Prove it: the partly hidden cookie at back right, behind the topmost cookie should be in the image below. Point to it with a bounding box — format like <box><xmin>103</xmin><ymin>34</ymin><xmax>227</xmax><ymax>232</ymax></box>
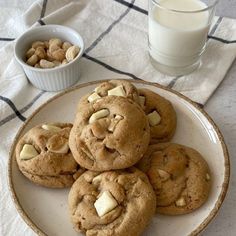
<box><xmin>138</xmin><ymin>89</ymin><xmax>177</xmax><ymax>143</ymax></box>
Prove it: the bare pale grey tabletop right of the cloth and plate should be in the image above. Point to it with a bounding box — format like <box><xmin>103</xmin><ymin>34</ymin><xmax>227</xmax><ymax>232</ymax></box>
<box><xmin>200</xmin><ymin>0</ymin><xmax>236</xmax><ymax>236</ymax></box>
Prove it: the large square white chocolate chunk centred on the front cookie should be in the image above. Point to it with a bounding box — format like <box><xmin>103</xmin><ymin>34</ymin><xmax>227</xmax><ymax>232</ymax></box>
<box><xmin>94</xmin><ymin>191</ymin><xmax>118</xmax><ymax>217</ymax></box>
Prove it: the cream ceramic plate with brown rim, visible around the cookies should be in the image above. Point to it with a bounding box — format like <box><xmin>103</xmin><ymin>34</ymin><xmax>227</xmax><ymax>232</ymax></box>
<box><xmin>9</xmin><ymin>81</ymin><xmax>229</xmax><ymax>236</ymax></box>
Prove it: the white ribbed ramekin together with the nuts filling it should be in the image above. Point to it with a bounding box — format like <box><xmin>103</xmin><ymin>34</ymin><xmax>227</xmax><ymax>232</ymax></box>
<box><xmin>15</xmin><ymin>25</ymin><xmax>84</xmax><ymax>91</ymax></box>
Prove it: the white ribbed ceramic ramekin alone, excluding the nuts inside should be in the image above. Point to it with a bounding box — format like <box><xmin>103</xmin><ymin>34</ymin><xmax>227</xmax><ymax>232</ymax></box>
<box><xmin>15</xmin><ymin>25</ymin><xmax>84</xmax><ymax>91</ymax></box>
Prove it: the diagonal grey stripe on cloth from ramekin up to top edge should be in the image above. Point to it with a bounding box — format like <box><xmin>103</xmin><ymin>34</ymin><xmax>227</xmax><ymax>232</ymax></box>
<box><xmin>84</xmin><ymin>0</ymin><xmax>135</xmax><ymax>53</ymax></box>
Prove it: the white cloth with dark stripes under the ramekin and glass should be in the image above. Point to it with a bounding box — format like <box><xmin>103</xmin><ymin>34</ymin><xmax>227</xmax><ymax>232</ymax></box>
<box><xmin>0</xmin><ymin>0</ymin><xmax>236</xmax><ymax>236</ymax></box>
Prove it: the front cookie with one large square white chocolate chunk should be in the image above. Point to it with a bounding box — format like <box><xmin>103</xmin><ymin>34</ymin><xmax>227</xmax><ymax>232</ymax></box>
<box><xmin>68</xmin><ymin>167</ymin><xmax>156</xmax><ymax>236</ymax></box>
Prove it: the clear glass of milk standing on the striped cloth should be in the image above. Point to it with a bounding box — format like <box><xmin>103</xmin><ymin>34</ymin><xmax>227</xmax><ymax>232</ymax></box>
<box><xmin>148</xmin><ymin>0</ymin><xmax>218</xmax><ymax>76</ymax></box>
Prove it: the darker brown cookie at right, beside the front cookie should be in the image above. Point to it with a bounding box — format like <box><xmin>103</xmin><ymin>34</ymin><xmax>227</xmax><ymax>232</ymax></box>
<box><xmin>137</xmin><ymin>143</ymin><xmax>211</xmax><ymax>215</ymax></box>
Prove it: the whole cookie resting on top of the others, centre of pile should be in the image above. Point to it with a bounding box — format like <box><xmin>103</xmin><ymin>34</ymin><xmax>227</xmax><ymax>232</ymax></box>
<box><xmin>69</xmin><ymin>96</ymin><xmax>150</xmax><ymax>171</ymax></box>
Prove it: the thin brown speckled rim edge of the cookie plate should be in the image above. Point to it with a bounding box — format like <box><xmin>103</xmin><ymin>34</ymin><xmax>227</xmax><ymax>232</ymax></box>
<box><xmin>7</xmin><ymin>78</ymin><xmax>230</xmax><ymax>236</ymax></box>
